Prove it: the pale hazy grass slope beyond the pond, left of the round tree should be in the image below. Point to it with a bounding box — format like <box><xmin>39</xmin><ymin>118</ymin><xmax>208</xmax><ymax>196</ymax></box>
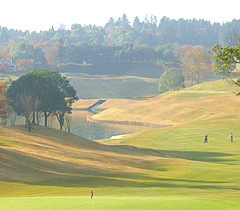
<box><xmin>63</xmin><ymin>73</ymin><xmax>159</xmax><ymax>99</ymax></box>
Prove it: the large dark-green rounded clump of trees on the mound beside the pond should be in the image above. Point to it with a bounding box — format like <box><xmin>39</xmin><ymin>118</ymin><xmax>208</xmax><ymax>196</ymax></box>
<box><xmin>7</xmin><ymin>69</ymin><xmax>78</xmax><ymax>129</ymax></box>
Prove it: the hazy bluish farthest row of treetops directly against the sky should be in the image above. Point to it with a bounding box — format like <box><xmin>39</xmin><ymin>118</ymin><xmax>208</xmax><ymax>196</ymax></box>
<box><xmin>0</xmin><ymin>14</ymin><xmax>240</xmax><ymax>48</ymax></box>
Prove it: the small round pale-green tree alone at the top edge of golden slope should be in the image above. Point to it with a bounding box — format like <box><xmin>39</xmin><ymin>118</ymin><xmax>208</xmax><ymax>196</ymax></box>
<box><xmin>158</xmin><ymin>67</ymin><xmax>184</xmax><ymax>92</ymax></box>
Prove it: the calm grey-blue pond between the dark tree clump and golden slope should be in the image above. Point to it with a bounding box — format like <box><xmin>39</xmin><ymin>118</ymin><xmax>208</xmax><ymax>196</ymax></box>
<box><xmin>13</xmin><ymin>111</ymin><xmax>153</xmax><ymax>140</ymax></box>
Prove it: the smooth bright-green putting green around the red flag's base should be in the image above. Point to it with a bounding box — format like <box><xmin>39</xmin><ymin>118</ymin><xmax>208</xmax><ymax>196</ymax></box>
<box><xmin>0</xmin><ymin>196</ymin><xmax>240</xmax><ymax>210</ymax></box>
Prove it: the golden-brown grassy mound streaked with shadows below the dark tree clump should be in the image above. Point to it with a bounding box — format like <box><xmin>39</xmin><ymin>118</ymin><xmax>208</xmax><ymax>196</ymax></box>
<box><xmin>0</xmin><ymin>126</ymin><xmax>168</xmax><ymax>197</ymax></box>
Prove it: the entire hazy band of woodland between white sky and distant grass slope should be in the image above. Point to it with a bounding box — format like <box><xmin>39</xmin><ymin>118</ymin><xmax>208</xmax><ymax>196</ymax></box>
<box><xmin>0</xmin><ymin>14</ymin><xmax>240</xmax><ymax>78</ymax></box>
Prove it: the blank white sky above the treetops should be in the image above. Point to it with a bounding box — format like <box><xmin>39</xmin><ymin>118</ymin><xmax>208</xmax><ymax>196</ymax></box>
<box><xmin>0</xmin><ymin>0</ymin><xmax>240</xmax><ymax>32</ymax></box>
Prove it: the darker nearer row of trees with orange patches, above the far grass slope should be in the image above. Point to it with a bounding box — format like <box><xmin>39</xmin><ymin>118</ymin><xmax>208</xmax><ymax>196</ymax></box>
<box><xmin>0</xmin><ymin>38</ymin><xmax>212</xmax><ymax>77</ymax></box>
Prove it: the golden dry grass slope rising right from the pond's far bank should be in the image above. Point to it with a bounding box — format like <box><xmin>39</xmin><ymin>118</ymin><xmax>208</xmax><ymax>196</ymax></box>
<box><xmin>92</xmin><ymin>81</ymin><xmax>240</xmax><ymax>125</ymax></box>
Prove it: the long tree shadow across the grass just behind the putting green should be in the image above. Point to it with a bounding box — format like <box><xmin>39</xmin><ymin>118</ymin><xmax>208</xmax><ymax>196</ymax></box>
<box><xmin>4</xmin><ymin>171</ymin><xmax>240</xmax><ymax>191</ymax></box>
